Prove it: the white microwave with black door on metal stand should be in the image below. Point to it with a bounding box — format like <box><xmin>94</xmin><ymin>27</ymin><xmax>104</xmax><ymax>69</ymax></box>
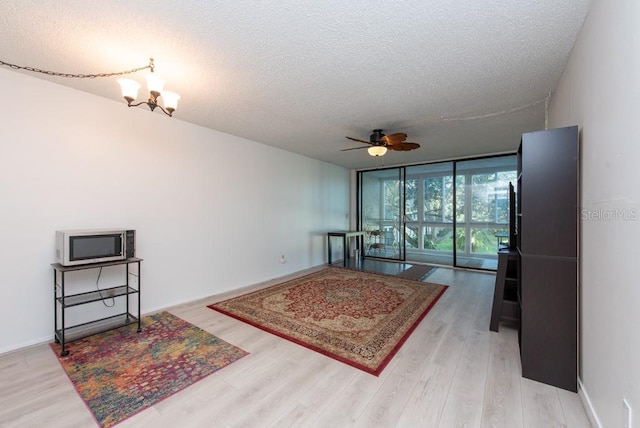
<box><xmin>56</xmin><ymin>229</ymin><xmax>136</xmax><ymax>266</ymax></box>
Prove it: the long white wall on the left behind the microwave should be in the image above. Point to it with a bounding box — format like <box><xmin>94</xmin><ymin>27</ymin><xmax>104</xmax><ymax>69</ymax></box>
<box><xmin>0</xmin><ymin>69</ymin><xmax>350</xmax><ymax>353</ymax></box>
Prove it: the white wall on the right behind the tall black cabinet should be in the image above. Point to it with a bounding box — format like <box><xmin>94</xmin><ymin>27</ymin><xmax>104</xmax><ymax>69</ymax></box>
<box><xmin>550</xmin><ymin>0</ymin><xmax>640</xmax><ymax>427</ymax></box>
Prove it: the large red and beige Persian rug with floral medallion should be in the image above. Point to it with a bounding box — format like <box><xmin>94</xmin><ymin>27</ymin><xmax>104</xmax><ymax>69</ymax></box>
<box><xmin>209</xmin><ymin>268</ymin><xmax>447</xmax><ymax>376</ymax></box>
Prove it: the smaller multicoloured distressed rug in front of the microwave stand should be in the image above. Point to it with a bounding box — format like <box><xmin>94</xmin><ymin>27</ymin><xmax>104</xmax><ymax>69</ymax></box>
<box><xmin>51</xmin><ymin>312</ymin><xmax>247</xmax><ymax>427</ymax></box>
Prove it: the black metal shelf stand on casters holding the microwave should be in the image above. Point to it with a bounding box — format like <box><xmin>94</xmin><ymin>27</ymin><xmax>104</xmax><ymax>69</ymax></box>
<box><xmin>51</xmin><ymin>257</ymin><xmax>142</xmax><ymax>356</ymax></box>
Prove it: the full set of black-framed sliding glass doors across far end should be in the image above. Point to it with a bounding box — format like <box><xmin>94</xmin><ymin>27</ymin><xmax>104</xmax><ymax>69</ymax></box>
<box><xmin>358</xmin><ymin>156</ymin><xmax>516</xmax><ymax>270</ymax></box>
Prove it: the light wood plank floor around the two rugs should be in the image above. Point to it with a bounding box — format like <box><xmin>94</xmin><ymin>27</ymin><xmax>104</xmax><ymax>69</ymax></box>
<box><xmin>0</xmin><ymin>268</ymin><xmax>589</xmax><ymax>428</ymax></box>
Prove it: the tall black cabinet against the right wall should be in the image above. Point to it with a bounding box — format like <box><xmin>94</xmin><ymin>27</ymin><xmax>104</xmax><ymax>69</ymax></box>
<box><xmin>517</xmin><ymin>126</ymin><xmax>579</xmax><ymax>391</ymax></box>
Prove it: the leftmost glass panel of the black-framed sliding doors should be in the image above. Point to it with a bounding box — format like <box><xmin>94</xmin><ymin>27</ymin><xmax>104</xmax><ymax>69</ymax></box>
<box><xmin>358</xmin><ymin>168</ymin><xmax>405</xmax><ymax>260</ymax></box>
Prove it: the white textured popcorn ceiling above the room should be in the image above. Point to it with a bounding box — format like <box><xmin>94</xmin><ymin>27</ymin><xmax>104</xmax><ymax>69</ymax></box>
<box><xmin>0</xmin><ymin>0</ymin><xmax>591</xmax><ymax>168</ymax></box>
